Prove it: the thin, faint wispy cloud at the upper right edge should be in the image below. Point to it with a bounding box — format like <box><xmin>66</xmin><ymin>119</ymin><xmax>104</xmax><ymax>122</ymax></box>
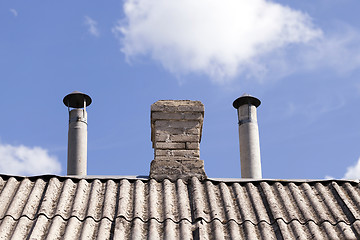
<box><xmin>272</xmin><ymin>23</ymin><xmax>360</xmax><ymax>75</ymax></box>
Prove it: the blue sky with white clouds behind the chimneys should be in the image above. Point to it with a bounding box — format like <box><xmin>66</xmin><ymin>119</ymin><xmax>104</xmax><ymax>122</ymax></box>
<box><xmin>0</xmin><ymin>0</ymin><xmax>360</xmax><ymax>179</ymax></box>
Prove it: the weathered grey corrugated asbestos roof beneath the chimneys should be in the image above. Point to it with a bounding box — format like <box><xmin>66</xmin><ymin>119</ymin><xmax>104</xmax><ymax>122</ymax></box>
<box><xmin>0</xmin><ymin>175</ymin><xmax>360</xmax><ymax>239</ymax></box>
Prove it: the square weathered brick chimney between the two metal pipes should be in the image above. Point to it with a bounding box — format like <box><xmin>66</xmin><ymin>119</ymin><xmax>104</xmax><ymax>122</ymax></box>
<box><xmin>150</xmin><ymin>100</ymin><xmax>206</xmax><ymax>180</ymax></box>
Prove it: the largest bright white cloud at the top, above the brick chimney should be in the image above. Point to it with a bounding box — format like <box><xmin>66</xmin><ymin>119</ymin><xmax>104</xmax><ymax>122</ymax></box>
<box><xmin>113</xmin><ymin>0</ymin><xmax>322</xmax><ymax>82</ymax></box>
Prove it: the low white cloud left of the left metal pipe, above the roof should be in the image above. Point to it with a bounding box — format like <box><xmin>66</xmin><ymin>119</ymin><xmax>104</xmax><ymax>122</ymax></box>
<box><xmin>0</xmin><ymin>144</ymin><xmax>61</xmax><ymax>175</ymax></box>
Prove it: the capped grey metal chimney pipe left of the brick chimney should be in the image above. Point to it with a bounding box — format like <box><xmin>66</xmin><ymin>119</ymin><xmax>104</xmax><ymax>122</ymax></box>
<box><xmin>63</xmin><ymin>91</ymin><xmax>92</xmax><ymax>175</ymax></box>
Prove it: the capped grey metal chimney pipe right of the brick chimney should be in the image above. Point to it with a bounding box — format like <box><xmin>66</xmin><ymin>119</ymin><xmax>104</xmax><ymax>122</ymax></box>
<box><xmin>233</xmin><ymin>94</ymin><xmax>262</xmax><ymax>179</ymax></box>
